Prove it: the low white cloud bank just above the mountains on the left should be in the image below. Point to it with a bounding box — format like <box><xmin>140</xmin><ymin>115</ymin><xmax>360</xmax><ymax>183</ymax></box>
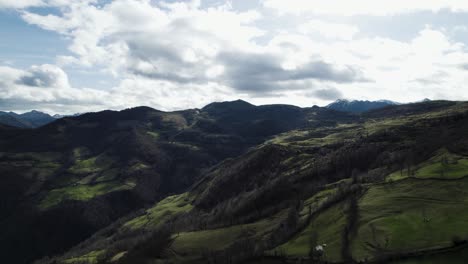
<box><xmin>0</xmin><ymin>65</ymin><xmax>238</xmax><ymax>113</ymax></box>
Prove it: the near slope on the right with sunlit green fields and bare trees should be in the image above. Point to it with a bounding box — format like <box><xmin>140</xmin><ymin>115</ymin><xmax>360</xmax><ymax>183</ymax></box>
<box><xmin>44</xmin><ymin>102</ymin><xmax>468</xmax><ymax>263</ymax></box>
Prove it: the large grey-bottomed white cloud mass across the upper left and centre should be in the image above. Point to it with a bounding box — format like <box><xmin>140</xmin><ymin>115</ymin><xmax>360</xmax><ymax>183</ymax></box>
<box><xmin>15</xmin><ymin>0</ymin><xmax>370</xmax><ymax>101</ymax></box>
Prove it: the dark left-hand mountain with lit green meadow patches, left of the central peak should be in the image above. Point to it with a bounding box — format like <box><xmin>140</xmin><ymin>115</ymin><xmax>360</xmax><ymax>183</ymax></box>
<box><xmin>0</xmin><ymin>108</ymin><xmax>218</xmax><ymax>263</ymax></box>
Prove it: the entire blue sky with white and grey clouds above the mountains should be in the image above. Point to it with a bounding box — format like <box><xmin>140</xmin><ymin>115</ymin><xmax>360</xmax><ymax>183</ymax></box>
<box><xmin>0</xmin><ymin>0</ymin><xmax>468</xmax><ymax>114</ymax></box>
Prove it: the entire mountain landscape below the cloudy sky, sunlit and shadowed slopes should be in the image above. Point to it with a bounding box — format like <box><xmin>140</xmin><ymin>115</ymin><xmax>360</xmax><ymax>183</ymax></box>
<box><xmin>0</xmin><ymin>100</ymin><xmax>468</xmax><ymax>264</ymax></box>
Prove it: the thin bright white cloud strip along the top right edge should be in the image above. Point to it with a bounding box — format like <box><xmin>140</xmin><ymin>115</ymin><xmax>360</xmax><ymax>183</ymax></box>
<box><xmin>263</xmin><ymin>0</ymin><xmax>468</xmax><ymax>16</ymax></box>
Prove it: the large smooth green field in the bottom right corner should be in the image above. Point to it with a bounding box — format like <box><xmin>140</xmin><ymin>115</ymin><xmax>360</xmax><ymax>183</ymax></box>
<box><xmin>352</xmin><ymin>176</ymin><xmax>468</xmax><ymax>260</ymax></box>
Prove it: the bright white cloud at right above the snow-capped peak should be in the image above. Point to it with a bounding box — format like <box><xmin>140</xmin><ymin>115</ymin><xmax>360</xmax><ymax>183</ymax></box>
<box><xmin>323</xmin><ymin>28</ymin><xmax>468</xmax><ymax>102</ymax></box>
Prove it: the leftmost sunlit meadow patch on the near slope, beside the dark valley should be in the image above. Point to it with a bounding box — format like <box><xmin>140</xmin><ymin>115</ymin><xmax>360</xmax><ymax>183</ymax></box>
<box><xmin>124</xmin><ymin>193</ymin><xmax>193</xmax><ymax>229</ymax></box>
